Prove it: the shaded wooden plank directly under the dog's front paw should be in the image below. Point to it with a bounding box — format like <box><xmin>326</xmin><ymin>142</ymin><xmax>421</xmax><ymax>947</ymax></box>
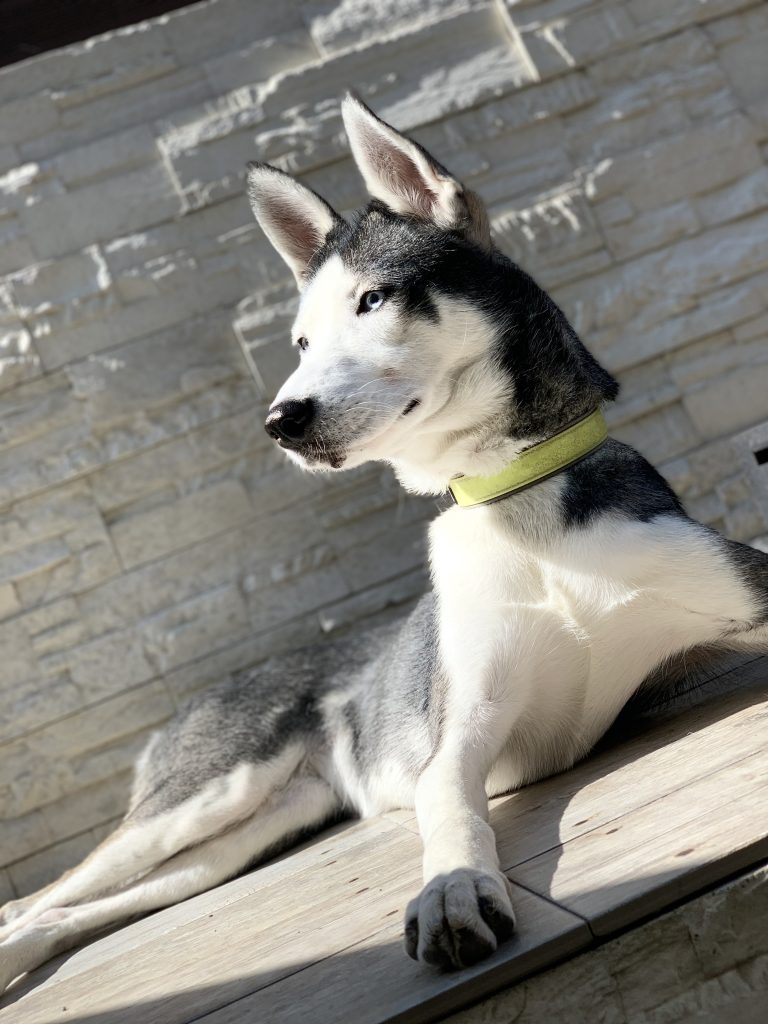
<box><xmin>195</xmin><ymin>887</ymin><xmax>593</xmax><ymax>1024</ymax></box>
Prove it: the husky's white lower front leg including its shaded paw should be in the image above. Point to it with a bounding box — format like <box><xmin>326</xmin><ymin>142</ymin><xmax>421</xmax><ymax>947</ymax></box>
<box><xmin>406</xmin><ymin>737</ymin><xmax>515</xmax><ymax>969</ymax></box>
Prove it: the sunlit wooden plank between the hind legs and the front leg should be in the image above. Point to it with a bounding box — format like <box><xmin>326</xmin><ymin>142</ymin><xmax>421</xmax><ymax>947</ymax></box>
<box><xmin>0</xmin><ymin>825</ymin><xmax>428</xmax><ymax>1024</ymax></box>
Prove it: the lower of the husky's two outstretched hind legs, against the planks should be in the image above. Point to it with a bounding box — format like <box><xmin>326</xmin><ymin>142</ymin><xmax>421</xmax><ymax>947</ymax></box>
<box><xmin>0</xmin><ymin>769</ymin><xmax>340</xmax><ymax>992</ymax></box>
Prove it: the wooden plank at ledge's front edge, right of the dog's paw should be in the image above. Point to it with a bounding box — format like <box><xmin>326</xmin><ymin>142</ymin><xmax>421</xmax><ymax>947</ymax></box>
<box><xmin>511</xmin><ymin>751</ymin><xmax>768</xmax><ymax>935</ymax></box>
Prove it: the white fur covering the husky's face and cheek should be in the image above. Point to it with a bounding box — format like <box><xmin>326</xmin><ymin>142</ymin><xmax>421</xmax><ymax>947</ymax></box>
<box><xmin>274</xmin><ymin>256</ymin><xmax>523</xmax><ymax>494</ymax></box>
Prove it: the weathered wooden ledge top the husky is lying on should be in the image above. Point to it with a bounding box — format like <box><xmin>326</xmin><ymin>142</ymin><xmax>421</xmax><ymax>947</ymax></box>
<box><xmin>0</xmin><ymin>658</ymin><xmax>768</xmax><ymax>1024</ymax></box>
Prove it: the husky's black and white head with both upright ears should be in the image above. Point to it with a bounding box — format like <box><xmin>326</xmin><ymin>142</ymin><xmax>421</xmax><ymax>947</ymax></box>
<box><xmin>248</xmin><ymin>96</ymin><xmax>609</xmax><ymax>490</ymax></box>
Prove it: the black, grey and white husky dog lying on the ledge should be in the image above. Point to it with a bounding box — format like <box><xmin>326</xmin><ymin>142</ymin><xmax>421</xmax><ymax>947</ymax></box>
<box><xmin>0</xmin><ymin>96</ymin><xmax>768</xmax><ymax>986</ymax></box>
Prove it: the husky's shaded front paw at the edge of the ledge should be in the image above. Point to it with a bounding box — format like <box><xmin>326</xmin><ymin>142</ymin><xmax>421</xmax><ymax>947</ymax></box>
<box><xmin>406</xmin><ymin>868</ymin><xmax>515</xmax><ymax>971</ymax></box>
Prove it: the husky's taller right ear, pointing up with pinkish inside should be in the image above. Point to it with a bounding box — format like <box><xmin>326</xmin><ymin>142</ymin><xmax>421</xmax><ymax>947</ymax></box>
<box><xmin>341</xmin><ymin>92</ymin><xmax>490</xmax><ymax>248</ymax></box>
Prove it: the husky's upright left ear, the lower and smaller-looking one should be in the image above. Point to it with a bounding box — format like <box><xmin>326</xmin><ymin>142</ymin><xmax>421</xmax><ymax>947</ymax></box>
<box><xmin>248</xmin><ymin>163</ymin><xmax>343</xmax><ymax>290</ymax></box>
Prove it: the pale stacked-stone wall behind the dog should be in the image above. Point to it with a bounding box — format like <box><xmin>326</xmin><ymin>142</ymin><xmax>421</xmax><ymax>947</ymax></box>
<box><xmin>0</xmin><ymin>0</ymin><xmax>768</xmax><ymax>897</ymax></box>
